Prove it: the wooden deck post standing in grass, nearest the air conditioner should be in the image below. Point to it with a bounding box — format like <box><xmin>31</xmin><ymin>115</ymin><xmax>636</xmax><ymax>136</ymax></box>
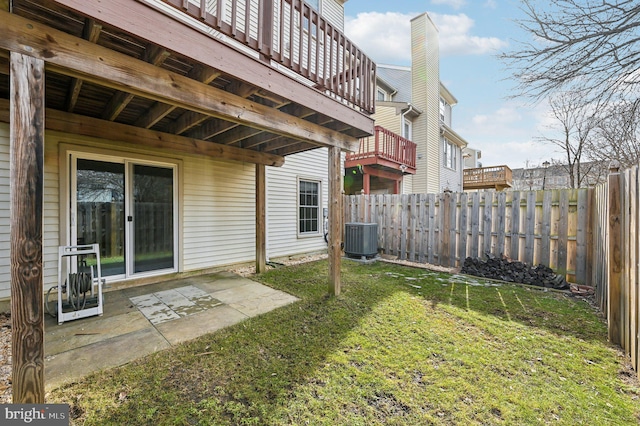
<box><xmin>329</xmin><ymin>146</ymin><xmax>343</xmax><ymax>296</ymax></box>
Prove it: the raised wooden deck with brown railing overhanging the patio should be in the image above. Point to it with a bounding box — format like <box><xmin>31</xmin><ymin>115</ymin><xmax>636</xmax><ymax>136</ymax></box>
<box><xmin>0</xmin><ymin>0</ymin><xmax>375</xmax><ymax>166</ymax></box>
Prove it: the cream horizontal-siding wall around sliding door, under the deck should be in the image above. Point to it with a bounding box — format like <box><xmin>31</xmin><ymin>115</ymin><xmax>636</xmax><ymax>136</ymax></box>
<box><xmin>0</xmin><ymin>123</ymin><xmax>328</xmax><ymax>300</ymax></box>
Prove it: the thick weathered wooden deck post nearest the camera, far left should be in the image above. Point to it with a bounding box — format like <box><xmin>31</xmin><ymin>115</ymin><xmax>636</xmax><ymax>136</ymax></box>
<box><xmin>9</xmin><ymin>52</ymin><xmax>44</xmax><ymax>404</ymax></box>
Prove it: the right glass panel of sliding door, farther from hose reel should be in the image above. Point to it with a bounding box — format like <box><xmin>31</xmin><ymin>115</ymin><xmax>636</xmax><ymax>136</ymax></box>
<box><xmin>133</xmin><ymin>164</ymin><xmax>174</xmax><ymax>272</ymax></box>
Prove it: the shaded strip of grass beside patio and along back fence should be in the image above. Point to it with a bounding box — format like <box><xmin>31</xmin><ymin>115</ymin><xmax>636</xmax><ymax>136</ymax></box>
<box><xmin>52</xmin><ymin>261</ymin><xmax>606</xmax><ymax>425</ymax></box>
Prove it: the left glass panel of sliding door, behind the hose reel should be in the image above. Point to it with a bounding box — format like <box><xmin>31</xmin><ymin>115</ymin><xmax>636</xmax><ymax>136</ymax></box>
<box><xmin>76</xmin><ymin>159</ymin><xmax>125</xmax><ymax>276</ymax></box>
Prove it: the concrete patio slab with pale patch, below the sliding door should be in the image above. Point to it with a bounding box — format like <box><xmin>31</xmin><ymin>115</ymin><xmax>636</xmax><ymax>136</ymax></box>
<box><xmin>45</xmin><ymin>272</ymin><xmax>298</xmax><ymax>390</ymax></box>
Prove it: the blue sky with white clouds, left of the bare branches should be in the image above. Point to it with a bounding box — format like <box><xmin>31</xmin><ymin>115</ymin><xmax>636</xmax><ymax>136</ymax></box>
<box><xmin>345</xmin><ymin>0</ymin><xmax>560</xmax><ymax>169</ymax></box>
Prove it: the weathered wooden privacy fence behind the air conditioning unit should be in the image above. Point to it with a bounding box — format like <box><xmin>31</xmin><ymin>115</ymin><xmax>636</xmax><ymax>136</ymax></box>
<box><xmin>345</xmin><ymin>189</ymin><xmax>591</xmax><ymax>284</ymax></box>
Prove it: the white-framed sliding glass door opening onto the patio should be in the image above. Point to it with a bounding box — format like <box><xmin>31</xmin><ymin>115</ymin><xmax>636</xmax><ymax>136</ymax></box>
<box><xmin>71</xmin><ymin>156</ymin><xmax>176</xmax><ymax>278</ymax></box>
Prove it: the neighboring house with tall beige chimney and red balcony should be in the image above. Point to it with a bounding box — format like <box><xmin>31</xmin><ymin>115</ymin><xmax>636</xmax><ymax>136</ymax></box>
<box><xmin>345</xmin><ymin>13</ymin><xmax>467</xmax><ymax>194</ymax></box>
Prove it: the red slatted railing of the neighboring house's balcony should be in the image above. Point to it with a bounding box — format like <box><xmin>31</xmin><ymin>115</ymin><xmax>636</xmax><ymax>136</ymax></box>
<box><xmin>346</xmin><ymin>126</ymin><xmax>416</xmax><ymax>171</ymax></box>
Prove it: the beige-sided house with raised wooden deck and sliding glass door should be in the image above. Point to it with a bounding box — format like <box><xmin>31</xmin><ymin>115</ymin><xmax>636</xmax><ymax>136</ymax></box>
<box><xmin>0</xmin><ymin>0</ymin><xmax>375</xmax><ymax>300</ymax></box>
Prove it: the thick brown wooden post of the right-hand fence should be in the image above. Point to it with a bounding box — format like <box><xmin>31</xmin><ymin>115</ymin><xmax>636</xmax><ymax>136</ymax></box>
<box><xmin>607</xmin><ymin>165</ymin><xmax>623</xmax><ymax>345</ymax></box>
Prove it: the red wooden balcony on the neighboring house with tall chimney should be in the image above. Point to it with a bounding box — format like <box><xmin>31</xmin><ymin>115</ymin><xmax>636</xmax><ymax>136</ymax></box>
<box><xmin>345</xmin><ymin>126</ymin><xmax>416</xmax><ymax>174</ymax></box>
